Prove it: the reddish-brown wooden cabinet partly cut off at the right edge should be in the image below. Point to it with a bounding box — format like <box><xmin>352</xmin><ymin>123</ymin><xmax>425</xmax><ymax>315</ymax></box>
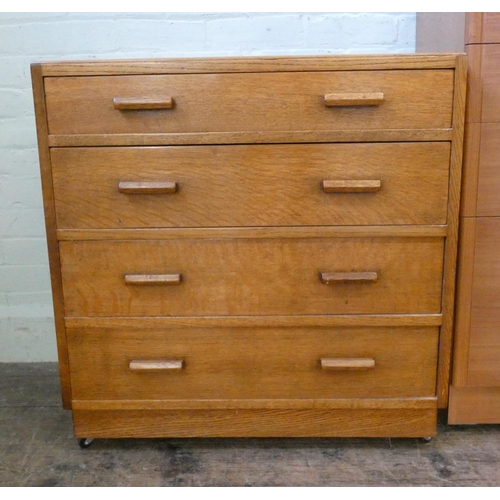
<box><xmin>449</xmin><ymin>13</ymin><xmax>500</xmax><ymax>423</ymax></box>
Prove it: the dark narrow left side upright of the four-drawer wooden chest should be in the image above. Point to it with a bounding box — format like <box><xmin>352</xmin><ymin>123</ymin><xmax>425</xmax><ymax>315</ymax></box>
<box><xmin>31</xmin><ymin>64</ymin><xmax>71</xmax><ymax>409</ymax></box>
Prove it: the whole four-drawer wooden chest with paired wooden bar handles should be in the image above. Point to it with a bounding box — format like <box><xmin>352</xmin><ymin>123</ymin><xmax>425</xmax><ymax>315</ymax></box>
<box><xmin>32</xmin><ymin>54</ymin><xmax>466</xmax><ymax>437</ymax></box>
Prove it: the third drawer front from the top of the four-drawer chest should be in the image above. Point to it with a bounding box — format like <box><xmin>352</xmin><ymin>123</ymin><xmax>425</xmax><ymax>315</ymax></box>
<box><xmin>60</xmin><ymin>237</ymin><xmax>443</xmax><ymax>316</ymax></box>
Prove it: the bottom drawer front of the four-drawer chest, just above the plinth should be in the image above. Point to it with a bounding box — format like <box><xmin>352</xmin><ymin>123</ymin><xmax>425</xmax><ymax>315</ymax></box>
<box><xmin>68</xmin><ymin>327</ymin><xmax>438</xmax><ymax>400</ymax></box>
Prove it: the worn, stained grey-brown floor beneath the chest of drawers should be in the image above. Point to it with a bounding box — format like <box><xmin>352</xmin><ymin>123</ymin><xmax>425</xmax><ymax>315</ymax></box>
<box><xmin>0</xmin><ymin>363</ymin><xmax>500</xmax><ymax>487</ymax></box>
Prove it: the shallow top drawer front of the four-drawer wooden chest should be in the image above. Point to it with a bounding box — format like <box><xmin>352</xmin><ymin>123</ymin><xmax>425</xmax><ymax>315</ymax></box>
<box><xmin>45</xmin><ymin>69</ymin><xmax>454</xmax><ymax>135</ymax></box>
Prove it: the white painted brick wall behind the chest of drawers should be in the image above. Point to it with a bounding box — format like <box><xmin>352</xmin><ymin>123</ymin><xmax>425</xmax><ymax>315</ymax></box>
<box><xmin>0</xmin><ymin>12</ymin><xmax>416</xmax><ymax>362</ymax></box>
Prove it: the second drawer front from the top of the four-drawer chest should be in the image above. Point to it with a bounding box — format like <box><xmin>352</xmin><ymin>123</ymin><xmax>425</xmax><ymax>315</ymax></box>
<box><xmin>51</xmin><ymin>143</ymin><xmax>450</xmax><ymax>229</ymax></box>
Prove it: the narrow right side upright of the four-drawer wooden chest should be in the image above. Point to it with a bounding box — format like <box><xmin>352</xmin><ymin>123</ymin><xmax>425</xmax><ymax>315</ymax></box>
<box><xmin>438</xmin><ymin>55</ymin><xmax>467</xmax><ymax>408</ymax></box>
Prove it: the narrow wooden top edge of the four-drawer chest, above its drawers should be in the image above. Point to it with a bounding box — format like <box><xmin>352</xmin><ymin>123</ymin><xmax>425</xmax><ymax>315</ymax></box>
<box><xmin>38</xmin><ymin>54</ymin><xmax>456</xmax><ymax>77</ymax></box>
